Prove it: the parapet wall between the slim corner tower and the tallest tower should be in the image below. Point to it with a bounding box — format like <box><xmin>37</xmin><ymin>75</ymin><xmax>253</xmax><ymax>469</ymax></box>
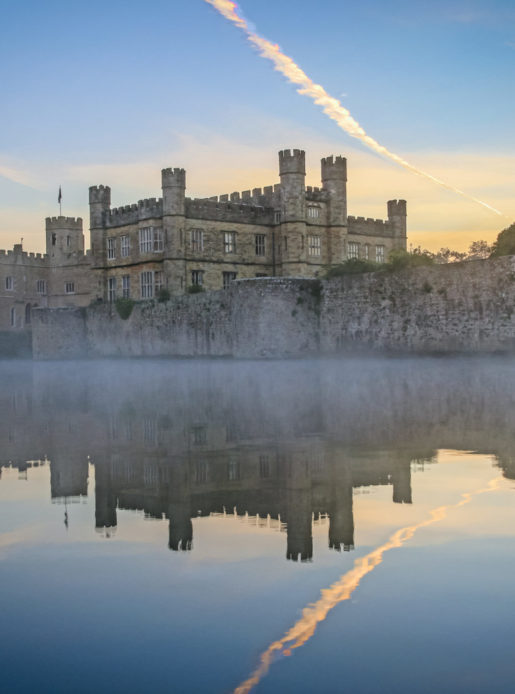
<box><xmin>186</xmin><ymin>195</ymin><xmax>275</xmax><ymax>224</ymax></box>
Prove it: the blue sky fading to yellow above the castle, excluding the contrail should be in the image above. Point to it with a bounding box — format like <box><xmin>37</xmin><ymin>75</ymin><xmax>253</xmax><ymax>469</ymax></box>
<box><xmin>0</xmin><ymin>0</ymin><xmax>515</xmax><ymax>252</ymax></box>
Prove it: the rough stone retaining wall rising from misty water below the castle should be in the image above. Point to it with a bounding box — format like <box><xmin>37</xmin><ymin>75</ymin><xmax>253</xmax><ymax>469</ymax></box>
<box><xmin>33</xmin><ymin>256</ymin><xmax>515</xmax><ymax>359</ymax></box>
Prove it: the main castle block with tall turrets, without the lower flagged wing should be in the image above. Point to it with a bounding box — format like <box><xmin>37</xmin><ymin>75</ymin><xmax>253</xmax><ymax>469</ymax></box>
<box><xmin>89</xmin><ymin>150</ymin><xmax>406</xmax><ymax>301</ymax></box>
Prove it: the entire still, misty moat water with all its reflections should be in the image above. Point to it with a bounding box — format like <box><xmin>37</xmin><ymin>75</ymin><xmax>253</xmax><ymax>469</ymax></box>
<box><xmin>0</xmin><ymin>358</ymin><xmax>515</xmax><ymax>694</ymax></box>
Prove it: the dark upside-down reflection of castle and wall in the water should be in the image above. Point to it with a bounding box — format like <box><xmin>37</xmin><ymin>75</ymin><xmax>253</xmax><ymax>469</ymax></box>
<box><xmin>0</xmin><ymin>359</ymin><xmax>515</xmax><ymax>561</ymax></box>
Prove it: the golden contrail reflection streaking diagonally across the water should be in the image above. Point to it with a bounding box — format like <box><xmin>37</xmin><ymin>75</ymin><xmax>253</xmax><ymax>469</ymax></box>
<box><xmin>234</xmin><ymin>477</ymin><xmax>502</xmax><ymax>694</ymax></box>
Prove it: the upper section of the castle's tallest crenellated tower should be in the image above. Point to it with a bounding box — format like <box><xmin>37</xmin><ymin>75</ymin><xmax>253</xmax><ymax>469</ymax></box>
<box><xmin>279</xmin><ymin>149</ymin><xmax>306</xmax><ymax>222</ymax></box>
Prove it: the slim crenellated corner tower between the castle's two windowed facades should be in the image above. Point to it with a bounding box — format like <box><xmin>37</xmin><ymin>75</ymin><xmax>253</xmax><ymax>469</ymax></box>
<box><xmin>161</xmin><ymin>168</ymin><xmax>189</xmax><ymax>294</ymax></box>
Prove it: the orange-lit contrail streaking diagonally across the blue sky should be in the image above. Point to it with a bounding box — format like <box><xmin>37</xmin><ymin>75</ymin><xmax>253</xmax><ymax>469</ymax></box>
<box><xmin>205</xmin><ymin>0</ymin><xmax>506</xmax><ymax>217</ymax></box>
